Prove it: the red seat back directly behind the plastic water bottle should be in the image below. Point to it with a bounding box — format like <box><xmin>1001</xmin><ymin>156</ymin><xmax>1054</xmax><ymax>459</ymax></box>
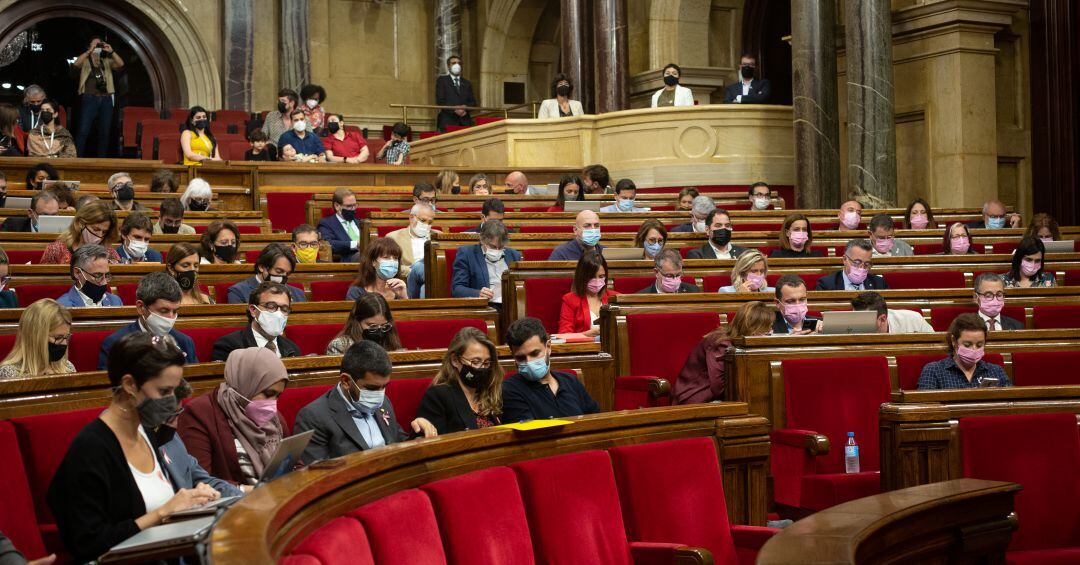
<box><xmin>782</xmin><ymin>357</ymin><xmax>892</xmax><ymax>473</ymax></box>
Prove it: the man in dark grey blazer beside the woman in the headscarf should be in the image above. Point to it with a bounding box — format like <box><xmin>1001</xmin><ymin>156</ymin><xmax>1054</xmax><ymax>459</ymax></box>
<box><xmin>293</xmin><ymin>339</ymin><xmax>437</xmax><ymax>465</ymax></box>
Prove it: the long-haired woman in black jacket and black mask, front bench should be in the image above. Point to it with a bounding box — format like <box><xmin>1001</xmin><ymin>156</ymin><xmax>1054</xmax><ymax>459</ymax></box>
<box><xmin>416</xmin><ymin>327</ymin><xmax>502</xmax><ymax>435</ymax></box>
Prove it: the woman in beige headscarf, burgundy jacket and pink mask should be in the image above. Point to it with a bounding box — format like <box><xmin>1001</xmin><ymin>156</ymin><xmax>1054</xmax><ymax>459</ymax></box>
<box><xmin>177</xmin><ymin>347</ymin><xmax>288</xmax><ymax>485</ymax></box>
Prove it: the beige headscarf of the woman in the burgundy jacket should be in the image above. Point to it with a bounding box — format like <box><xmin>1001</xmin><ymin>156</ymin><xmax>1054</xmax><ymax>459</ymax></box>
<box><xmin>217</xmin><ymin>347</ymin><xmax>288</xmax><ymax>479</ymax></box>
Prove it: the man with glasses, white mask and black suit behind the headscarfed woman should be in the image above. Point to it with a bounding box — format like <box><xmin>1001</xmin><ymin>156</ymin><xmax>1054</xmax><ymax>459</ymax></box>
<box><xmin>212</xmin><ymin>282</ymin><xmax>300</xmax><ymax>361</ymax></box>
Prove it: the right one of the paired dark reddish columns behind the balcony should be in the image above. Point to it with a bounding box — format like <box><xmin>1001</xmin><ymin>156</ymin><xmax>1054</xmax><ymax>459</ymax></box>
<box><xmin>593</xmin><ymin>0</ymin><xmax>630</xmax><ymax>113</ymax></box>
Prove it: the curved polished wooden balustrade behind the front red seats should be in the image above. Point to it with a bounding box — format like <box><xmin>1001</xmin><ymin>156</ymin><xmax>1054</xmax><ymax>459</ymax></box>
<box><xmin>208</xmin><ymin>403</ymin><xmax>769</xmax><ymax>565</ymax></box>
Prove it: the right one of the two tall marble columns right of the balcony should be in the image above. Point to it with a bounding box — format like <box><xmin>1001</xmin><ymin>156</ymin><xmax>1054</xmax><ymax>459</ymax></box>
<box><xmin>843</xmin><ymin>0</ymin><xmax>896</xmax><ymax>207</ymax></box>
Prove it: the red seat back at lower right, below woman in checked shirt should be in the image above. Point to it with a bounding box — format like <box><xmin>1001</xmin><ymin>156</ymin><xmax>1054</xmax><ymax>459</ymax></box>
<box><xmin>960</xmin><ymin>414</ymin><xmax>1080</xmax><ymax>550</ymax></box>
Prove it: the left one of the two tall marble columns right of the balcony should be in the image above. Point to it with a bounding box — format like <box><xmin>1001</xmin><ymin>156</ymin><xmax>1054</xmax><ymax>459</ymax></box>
<box><xmin>792</xmin><ymin>0</ymin><xmax>840</xmax><ymax>208</ymax></box>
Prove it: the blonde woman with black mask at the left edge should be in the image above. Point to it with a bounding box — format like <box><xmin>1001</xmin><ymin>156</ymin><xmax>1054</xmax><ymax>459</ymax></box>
<box><xmin>0</xmin><ymin>298</ymin><xmax>75</xmax><ymax>380</ymax></box>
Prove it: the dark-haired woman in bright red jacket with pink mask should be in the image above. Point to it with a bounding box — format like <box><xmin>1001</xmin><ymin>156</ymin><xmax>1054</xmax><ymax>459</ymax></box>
<box><xmin>558</xmin><ymin>251</ymin><xmax>619</xmax><ymax>337</ymax></box>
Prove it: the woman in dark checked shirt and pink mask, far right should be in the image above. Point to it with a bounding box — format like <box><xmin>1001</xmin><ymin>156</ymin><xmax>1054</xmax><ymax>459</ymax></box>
<box><xmin>919</xmin><ymin>313</ymin><xmax>1012</xmax><ymax>390</ymax></box>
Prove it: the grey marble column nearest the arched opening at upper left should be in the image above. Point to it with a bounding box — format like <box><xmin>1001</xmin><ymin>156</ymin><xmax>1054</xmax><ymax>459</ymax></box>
<box><xmin>221</xmin><ymin>0</ymin><xmax>255</xmax><ymax>110</ymax></box>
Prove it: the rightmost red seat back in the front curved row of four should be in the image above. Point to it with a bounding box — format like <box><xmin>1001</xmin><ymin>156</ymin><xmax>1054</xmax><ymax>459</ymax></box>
<box><xmin>608</xmin><ymin>438</ymin><xmax>739</xmax><ymax>565</ymax></box>
